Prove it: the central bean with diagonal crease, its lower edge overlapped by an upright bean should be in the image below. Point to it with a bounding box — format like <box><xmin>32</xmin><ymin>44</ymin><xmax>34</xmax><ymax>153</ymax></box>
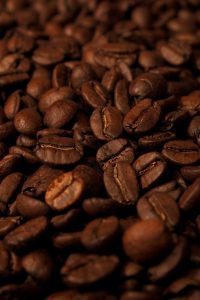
<box><xmin>96</xmin><ymin>138</ymin><xmax>135</xmax><ymax>170</ymax></box>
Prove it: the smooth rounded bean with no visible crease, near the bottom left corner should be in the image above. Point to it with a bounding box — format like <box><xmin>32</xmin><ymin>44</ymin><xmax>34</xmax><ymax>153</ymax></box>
<box><xmin>22</xmin><ymin>249</ymin><xmax>54</xmax><ymax>283</ymax></box>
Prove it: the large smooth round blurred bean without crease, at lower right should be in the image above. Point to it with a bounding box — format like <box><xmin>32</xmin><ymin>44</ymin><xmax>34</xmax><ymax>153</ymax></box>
<box><xmin>122</xmin><ymin>219</ymin><xmax>172</xmax><ymax>263</ymax></box>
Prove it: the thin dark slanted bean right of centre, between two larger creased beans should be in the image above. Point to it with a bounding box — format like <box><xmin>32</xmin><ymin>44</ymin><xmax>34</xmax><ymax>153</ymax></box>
<box><xmin>138</xmin><ymin>131</ymin><xmax>176</xmax><ymax>150</ymax></box>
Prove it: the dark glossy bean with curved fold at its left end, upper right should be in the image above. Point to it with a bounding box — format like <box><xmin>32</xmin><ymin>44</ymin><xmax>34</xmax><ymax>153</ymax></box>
<box><xmin>129</xmin><ymin>72</ymin><xmax>167</xmax><ymax>101</ymax></box>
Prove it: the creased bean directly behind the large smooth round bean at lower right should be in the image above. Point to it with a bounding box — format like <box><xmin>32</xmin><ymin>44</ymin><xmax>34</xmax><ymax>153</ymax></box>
<box><xmin>137</xmin><ymin>192</ymin><xmax>180</xmax><ymax>229</ymax></box>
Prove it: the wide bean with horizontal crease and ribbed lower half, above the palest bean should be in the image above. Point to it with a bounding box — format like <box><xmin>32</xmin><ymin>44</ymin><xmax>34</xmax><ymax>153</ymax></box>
<box><xmin>35</xmin><ymin>136</ymin><xmax>83</xmax><ymax>166</ymax></box>
